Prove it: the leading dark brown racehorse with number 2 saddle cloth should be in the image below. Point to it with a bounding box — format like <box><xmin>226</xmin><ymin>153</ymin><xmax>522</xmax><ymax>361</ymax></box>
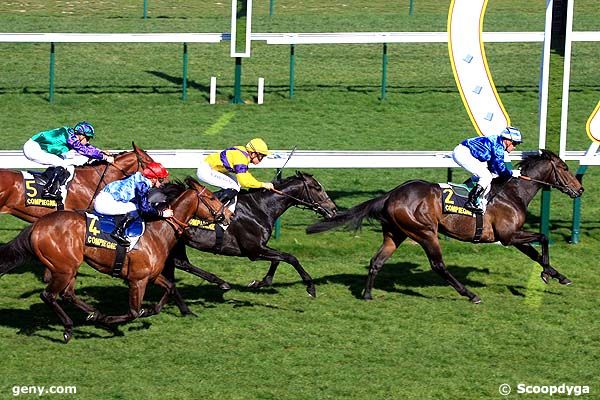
<box><xmin>307</xmin><ymin>150</ymin><xmax>583</xmax><ymax>303</ymax></box>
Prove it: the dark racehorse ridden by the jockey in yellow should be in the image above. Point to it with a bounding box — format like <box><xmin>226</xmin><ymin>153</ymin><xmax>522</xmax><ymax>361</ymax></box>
<box><xmin>163</xmin><ymin>172</ymin><xmax>337</xmax><ymax>297</ymax></box>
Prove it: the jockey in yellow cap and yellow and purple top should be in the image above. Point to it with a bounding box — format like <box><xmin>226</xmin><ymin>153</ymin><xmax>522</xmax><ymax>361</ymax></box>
<box><xmin>196</xmin><ymin>138</ymin><xmax>273</xmax><ymax>211</ymax></box>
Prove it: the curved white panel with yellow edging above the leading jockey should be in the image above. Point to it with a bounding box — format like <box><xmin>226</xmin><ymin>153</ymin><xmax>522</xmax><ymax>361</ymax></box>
<box><xmin>448</xmin><ymin>0</ymin><xmax>510</xmax><ymax>135</ymax></box>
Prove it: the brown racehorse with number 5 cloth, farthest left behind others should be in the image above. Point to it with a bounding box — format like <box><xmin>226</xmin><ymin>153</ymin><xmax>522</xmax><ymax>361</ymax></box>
<box><xmin>0</xmin><ymin>143</ymin><xmax>154</xmax><ymax>222</ymax></box>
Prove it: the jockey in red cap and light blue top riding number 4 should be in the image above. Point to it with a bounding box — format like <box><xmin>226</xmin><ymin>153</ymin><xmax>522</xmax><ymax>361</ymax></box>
<box><xmin>94</xmin><ymin>162</ymin><xmax>173</xmax><ymax>246</ymax></box>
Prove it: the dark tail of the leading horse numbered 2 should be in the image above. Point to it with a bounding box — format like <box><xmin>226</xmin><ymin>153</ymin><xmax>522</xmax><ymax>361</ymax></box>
<box><xmin>306</xmin><ymin>192</ymin><xmax>391</xmax><ymax>234</ymax></box>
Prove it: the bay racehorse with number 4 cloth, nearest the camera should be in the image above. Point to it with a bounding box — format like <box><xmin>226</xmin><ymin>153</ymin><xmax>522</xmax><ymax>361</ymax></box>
<box><xmin>0</xmin><ymin>179</ymin><xmax>224</xmax><ymax>342</ymax></box>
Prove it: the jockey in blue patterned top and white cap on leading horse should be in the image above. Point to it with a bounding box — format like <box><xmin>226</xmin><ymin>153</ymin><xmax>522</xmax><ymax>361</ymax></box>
<box><xmin>452</xmin><ymin>126</ymin><xmax>523</xmax><ymax>213</ymax></box>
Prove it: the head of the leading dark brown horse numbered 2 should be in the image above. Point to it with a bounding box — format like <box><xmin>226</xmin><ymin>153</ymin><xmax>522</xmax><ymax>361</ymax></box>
<box><xmin>519</xmin><ymin>150</ymin><xmax>583</xmax><ymax>198</ymax></box>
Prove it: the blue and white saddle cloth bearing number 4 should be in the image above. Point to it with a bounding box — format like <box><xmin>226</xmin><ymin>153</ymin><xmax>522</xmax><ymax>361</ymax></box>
<box><xmin>85</xmin><ymin>212</ymin><xmax>146</xmax><ymax>251</ymax></box>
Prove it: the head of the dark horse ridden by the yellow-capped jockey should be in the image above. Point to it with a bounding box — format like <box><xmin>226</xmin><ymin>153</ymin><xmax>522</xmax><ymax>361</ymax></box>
<box><xmin>276</xmin><ymin>171</ymin><xmax>337</xmax><ymax>218</ymax></box>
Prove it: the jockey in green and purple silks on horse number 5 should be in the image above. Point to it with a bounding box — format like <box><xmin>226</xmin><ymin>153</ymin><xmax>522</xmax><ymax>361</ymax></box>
<box><xmin>23</xmin><ymin>121</ymin><xmax>115</xmax><ymax>199</ymax></box>
